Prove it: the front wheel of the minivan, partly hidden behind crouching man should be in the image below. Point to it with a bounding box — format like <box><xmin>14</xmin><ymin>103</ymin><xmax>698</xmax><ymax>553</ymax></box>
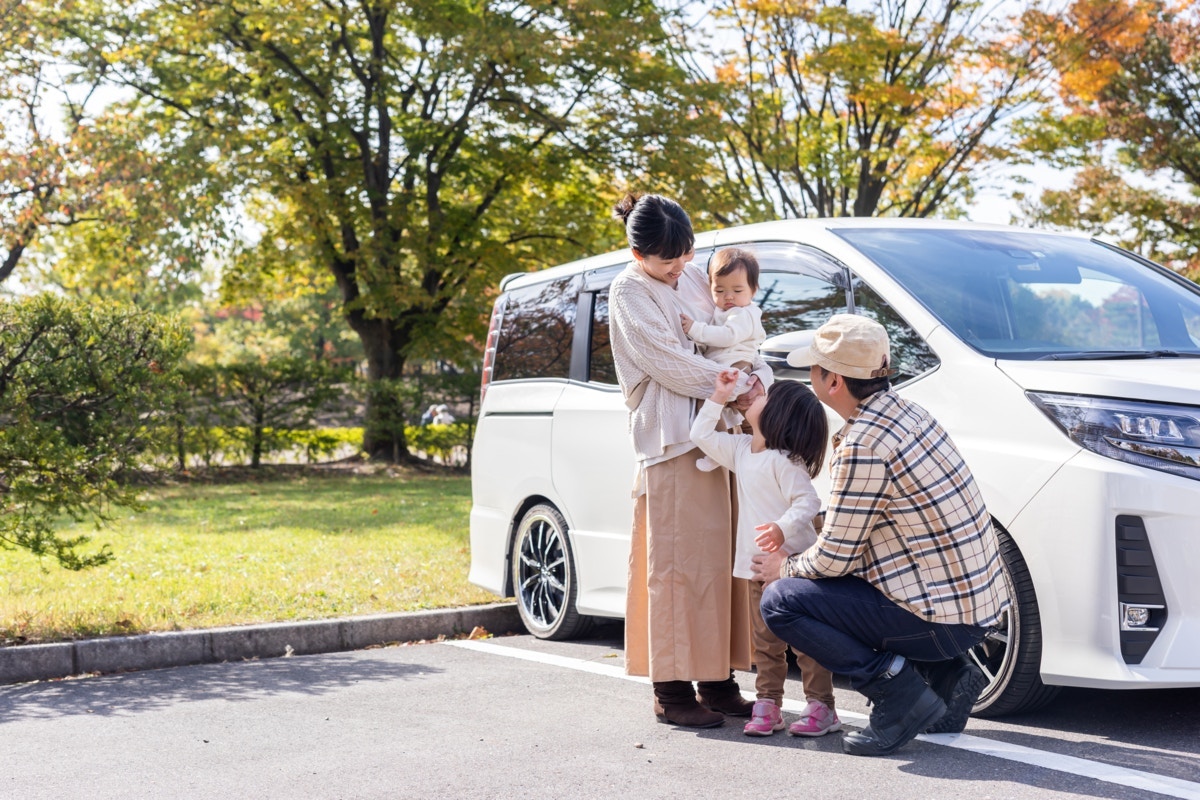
<box><xmin>967</xmin><ymin>530</ymin><xmax>1061</xmax><ymax>717</ymax></box>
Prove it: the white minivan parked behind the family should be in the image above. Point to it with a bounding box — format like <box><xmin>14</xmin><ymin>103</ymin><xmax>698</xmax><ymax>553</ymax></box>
<box><xmin>469</xmin><ymin>218</ymin><xmax>1200</xmax><ymax>716</ymax></box>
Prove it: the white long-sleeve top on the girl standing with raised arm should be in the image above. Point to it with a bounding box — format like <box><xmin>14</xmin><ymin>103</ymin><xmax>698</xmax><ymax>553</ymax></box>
<box><xmin>691</xmin><ymin>399</ymin><xmax>821</xmax><ymax>578</ymax></box>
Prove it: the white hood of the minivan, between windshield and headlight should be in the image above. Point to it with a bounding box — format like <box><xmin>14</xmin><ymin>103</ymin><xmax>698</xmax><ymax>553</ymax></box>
<box><xmin>996</xmin><ymin>359</ymin><xmax>1200</xmax><ymax>405</ymax></box>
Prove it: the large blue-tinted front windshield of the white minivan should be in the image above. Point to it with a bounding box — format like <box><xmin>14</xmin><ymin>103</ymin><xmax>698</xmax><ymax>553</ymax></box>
<box><xmin>836</xmin><ymin>228</ymin><xmax>1200</xmax><ymax>360</ymax></box>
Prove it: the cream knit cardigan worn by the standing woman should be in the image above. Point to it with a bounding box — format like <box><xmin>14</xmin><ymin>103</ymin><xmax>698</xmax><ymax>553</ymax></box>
<box><xmin>608</xmin><ymin>261</ymin><xmax>770</xmax><ymax>462</ymax></box>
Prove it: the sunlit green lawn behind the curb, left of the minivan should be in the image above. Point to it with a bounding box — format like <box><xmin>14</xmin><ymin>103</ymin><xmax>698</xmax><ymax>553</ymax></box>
<box><xmin>0</xmin><ymin>475</ymin><xmax>498</xmax><ymax>643</ymax></box>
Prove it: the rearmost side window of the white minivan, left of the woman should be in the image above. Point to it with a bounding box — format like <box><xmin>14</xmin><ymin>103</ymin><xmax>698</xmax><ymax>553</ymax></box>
<box><xmin>492</xmin><ymin>276</ymin><xmax>581</xmax><ymax>380</ymax></box>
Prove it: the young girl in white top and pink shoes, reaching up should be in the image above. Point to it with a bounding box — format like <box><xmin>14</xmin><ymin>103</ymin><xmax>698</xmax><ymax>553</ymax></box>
<box><xmin>691</xmin><ymin>371</ymin><xmax>841</xmax><ymax>736</ymax></box>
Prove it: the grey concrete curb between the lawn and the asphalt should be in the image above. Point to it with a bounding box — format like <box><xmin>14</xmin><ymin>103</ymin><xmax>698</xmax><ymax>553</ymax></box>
<box><xmin>0</xmin><ymin>603</ymin><xmax>524</xmax><ymax>685</ymax></box>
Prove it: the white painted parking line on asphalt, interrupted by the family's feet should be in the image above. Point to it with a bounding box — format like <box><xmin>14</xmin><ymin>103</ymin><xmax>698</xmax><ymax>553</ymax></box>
<box><xmin>445</xmin><ymin>639</ymin><xmax>1200</xmax><ymax>800</ymax></box>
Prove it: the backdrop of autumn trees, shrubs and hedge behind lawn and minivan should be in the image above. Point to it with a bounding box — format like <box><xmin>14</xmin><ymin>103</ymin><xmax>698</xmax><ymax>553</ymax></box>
<box><xmin>0</xmin><ymin>0</ymin><xmax>1200</xmax><ymax>579</ymax></box>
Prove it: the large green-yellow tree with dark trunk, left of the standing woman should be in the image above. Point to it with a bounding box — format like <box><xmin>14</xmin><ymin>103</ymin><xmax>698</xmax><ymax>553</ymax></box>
<box><xmin>40</xmin><ymin>0</ymin><xmax>688</xmax><ymax>456</ymax></box>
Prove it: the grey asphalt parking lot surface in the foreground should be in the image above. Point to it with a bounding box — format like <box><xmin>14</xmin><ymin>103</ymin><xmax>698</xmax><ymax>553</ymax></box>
<box><xmin>0</xmin><ymin>625</ymin><xmax>1200</xmax><ymax>800</ymax></box>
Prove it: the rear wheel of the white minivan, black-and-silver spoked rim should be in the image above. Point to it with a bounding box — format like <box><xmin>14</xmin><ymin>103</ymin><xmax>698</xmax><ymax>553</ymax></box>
<box><xmin>511</xmin><ymin>504</ymin><xmax>592</xmax><ymax>639</ymax></box>
